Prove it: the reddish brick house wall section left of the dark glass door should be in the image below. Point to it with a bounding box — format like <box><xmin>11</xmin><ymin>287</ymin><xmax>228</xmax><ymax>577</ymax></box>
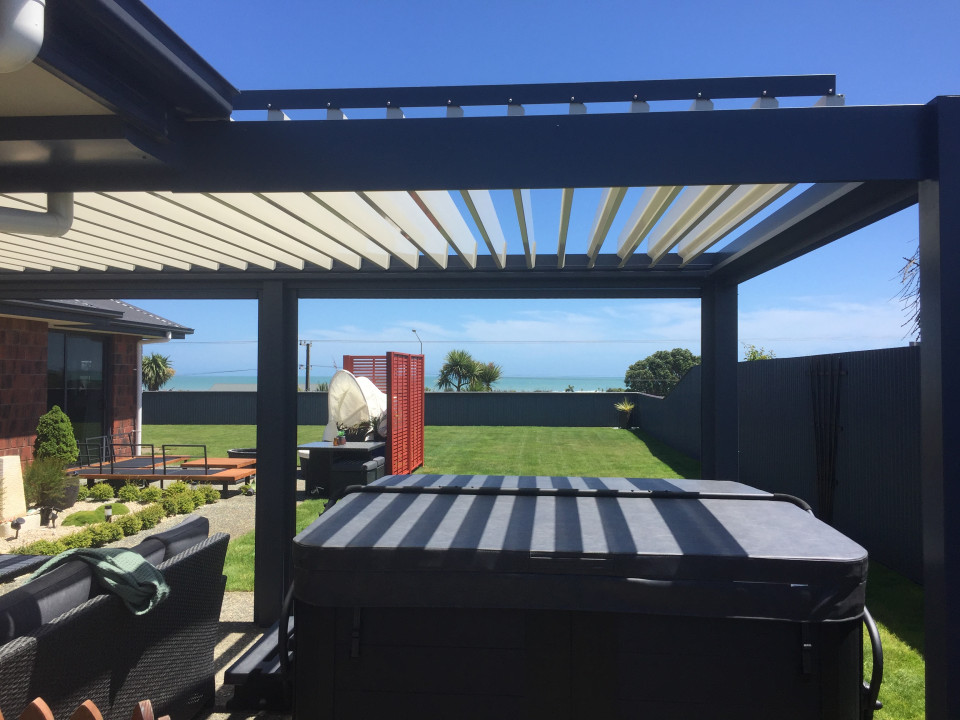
<box><xmin>0</xmin><ymin>317</ymin><xmax>47</xmax><ymax>462</ymax></box>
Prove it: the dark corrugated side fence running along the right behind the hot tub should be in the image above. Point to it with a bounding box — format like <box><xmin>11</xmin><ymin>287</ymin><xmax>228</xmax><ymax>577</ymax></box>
<box><xmin>638</xmin><ymin>347</ymin><xmax>923</xmax><ymax>581</ymax></box>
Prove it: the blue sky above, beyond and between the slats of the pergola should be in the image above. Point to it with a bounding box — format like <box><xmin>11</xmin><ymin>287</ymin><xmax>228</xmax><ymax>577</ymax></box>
<box><xmin>134</xmin><ymin>0</ymin><xmax>960</xmax><ymax>379</ymax></box>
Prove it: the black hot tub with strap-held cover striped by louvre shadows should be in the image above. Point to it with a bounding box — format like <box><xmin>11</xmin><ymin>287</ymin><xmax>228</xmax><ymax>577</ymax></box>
<box><xmin>294</xmin><ymin>475</ymin><xmax>867</xmax><ymax>720</ymax></box>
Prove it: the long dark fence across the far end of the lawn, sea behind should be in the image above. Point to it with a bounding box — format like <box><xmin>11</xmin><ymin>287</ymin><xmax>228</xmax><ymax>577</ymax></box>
<box><xmin>143</xmin><ymin>391</ymin><xmax>645</xmax><ymax>427</ymax></box>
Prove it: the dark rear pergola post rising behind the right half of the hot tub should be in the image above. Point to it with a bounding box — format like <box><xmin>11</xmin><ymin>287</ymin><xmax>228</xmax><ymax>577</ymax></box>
<box><xmin>700</xmin><ymin>282</ymin><xmax>740</xmax><ymax>480</ymax></box>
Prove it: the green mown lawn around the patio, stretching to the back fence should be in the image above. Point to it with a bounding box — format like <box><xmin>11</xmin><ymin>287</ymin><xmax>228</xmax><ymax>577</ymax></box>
<box><xmin>143</xmin><ymin>425</ymin><xmax>924</xmax><ymax>720</ymax></box>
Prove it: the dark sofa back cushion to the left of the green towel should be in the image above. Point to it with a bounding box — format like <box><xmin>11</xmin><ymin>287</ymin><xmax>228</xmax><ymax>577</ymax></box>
<box><xmin>0</xmin><ymin>561</ymin><xmax>99</xmax><ymax>645</ymax></box>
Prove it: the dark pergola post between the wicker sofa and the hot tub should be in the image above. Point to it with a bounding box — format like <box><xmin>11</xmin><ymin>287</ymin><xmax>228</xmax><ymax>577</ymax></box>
<box><xmin>253</xmin><ymin>281</ymin><xmax>297</xmax><ymax>627</ymax></box>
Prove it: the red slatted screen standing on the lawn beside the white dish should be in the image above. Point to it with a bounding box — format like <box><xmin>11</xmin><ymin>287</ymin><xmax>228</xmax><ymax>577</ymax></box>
<box><xmin>343</xmin><ymin>352</ymin><xmax>424</xmax><ymax>475</ymax></box>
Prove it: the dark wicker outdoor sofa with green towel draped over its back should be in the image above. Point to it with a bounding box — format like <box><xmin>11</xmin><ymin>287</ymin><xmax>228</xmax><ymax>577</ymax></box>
<box><xmin>0</xmin><ymin>533</ymin><xmax>229</xmax><ymax>720</ymax></box>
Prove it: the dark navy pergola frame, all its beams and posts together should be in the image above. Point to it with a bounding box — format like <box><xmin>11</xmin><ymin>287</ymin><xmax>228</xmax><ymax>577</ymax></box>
<box><xmin>0</xmin><ymin>5</ymin><xmax>960</xmax><ymax>718</ymax></box>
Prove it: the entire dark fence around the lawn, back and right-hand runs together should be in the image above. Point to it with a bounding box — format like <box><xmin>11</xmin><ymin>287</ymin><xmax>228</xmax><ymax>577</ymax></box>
<box><xmin>143</xmin><ymin>347</ymin><xmax>923</xmax><ymax>581</ymax></box>
